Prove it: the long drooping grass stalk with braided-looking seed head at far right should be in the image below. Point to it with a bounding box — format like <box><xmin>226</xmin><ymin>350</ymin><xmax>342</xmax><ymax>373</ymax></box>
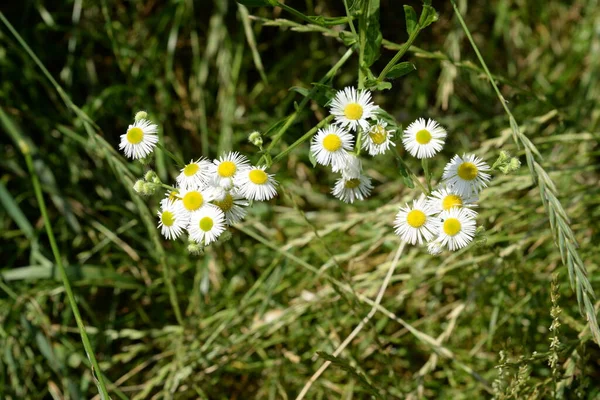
<box><xmin>451</xmin><ymin>0</ymin><xmax>600</xmax><ymax>344</ymax></box>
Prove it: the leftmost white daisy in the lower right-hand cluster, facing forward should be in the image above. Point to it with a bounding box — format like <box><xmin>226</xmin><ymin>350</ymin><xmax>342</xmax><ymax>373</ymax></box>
<box><xmin>394</xmin><ymin>196</ymin><xmax>439</xmax><ymax>244</ymax></box>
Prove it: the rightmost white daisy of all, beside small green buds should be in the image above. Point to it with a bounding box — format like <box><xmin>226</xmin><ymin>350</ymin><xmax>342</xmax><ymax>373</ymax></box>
<box><xmin>442</xmin><ymin>154</ymin><xmax>491</xmax><ymax>197</ymax></box>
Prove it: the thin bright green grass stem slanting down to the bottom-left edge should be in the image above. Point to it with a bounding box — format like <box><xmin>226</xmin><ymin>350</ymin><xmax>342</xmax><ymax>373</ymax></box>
<box><xmin>21</xmin><ymin>144</ymin><xmax>110</xmax><ymax>399</ymax></box>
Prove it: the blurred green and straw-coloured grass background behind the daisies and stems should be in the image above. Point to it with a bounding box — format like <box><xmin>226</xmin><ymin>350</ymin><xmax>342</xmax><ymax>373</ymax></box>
<box><xmin>0</xmin><ymin>0</ymin><xmax>600</xmax><ymax>399</ymax></box>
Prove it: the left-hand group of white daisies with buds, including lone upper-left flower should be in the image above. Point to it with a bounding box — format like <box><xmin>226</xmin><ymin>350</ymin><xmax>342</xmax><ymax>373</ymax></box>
<box><xmin>119</xmin><ymin>112</ymin><xmax>277</xmax><ymax>249</ymax></box>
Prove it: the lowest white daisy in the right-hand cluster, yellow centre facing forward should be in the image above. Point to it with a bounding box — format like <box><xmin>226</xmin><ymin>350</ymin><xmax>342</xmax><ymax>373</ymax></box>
<box><xmin>438</xmin><ymin>207</ymin><xmax>475</xmax><ymax>251</ymax></box>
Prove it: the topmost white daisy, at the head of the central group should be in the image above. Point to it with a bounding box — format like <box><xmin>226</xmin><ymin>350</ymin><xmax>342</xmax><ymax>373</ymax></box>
<box><xmin>331</xmin><ymin>87</ymin><xmax>379</xmax><ymax>130</ymax></box>
